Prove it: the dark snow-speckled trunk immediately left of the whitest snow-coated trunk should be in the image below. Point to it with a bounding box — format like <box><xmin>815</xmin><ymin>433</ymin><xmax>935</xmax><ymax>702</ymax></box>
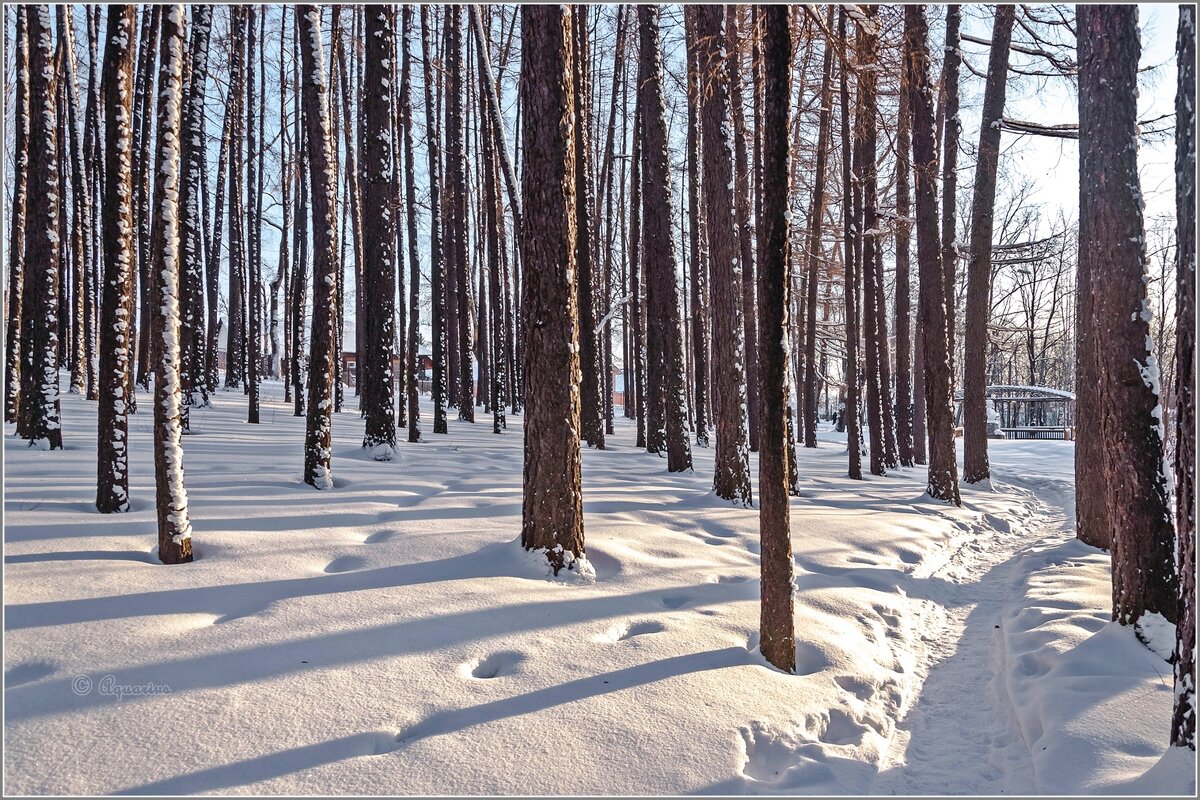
<box><xmin>96</xmin><ymin>6</ymin><xmax>137</xmax><ymax>513</ymax></box>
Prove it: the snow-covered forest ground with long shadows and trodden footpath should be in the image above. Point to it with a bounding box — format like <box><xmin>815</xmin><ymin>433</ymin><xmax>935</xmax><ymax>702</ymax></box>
<box><xmin>4</xmin><ymin>383</ymin><xmax>1195</xmax><ymax>794</ymax></box>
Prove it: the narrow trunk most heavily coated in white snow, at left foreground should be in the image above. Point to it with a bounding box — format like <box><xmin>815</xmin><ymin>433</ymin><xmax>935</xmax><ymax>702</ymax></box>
<box><xmin>150</xmin><ymin>5</ymin><xmax>192</xmax><ymax>564</ymax></box>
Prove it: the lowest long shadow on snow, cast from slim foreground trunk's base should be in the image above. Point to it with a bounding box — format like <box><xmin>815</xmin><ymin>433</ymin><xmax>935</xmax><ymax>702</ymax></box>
<box><xmin>116</xmin><ymin>646</ymin><xmax>755</xmax><ymax>794</ymax></box>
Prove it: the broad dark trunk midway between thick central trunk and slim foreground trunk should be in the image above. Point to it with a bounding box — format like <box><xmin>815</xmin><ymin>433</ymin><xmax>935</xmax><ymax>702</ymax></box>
<box><xmin>637</xmin><ymin>6</ymin><xmax>691</xmax><ymax>473</ymax></box>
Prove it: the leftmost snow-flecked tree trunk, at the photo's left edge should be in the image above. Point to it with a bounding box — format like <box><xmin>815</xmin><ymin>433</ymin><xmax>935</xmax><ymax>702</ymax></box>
<box><xmin>4</xmin><ymin>5</ymin><xmax>32</xmax><ymax>434</ymax></box>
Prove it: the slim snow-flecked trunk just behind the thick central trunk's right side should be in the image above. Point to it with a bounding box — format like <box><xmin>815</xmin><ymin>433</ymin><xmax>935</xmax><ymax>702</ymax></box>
<box><xmin>571</xmin><ymin>5</ymin><xmax>605</xmax><ymax>450</ymax></box>
